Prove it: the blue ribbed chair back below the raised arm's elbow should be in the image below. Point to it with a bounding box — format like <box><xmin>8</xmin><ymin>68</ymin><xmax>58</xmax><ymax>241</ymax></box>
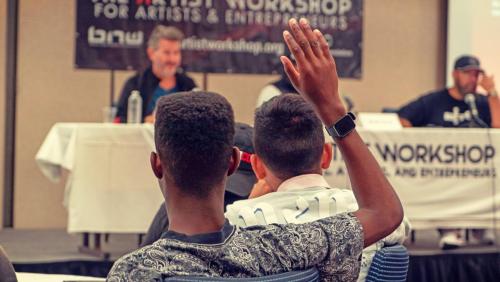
<box><xmin>365</xmin><ymin>244</ymin><xmax>410</xmax><ymax>282</ymax></box>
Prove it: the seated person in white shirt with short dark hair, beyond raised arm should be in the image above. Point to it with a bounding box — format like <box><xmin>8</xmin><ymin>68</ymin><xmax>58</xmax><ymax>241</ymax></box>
<box><xmin>226</xmin><ymin>94</ymin><xmax>409</xmax><ymax>281</ymax></box>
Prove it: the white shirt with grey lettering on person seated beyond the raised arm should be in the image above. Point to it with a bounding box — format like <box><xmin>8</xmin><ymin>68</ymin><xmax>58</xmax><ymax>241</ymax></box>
<box><xmin>226</xmin><ymin>174</ymin><xmax>410</xmax><ymax>282</ymax></box>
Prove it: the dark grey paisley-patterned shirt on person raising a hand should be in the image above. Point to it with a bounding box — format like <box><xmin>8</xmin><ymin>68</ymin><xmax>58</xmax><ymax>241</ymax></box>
<box><xmin>108</xmin><ymin>213</ymin><xmax>363</xmax><ymax>281</ymax></box>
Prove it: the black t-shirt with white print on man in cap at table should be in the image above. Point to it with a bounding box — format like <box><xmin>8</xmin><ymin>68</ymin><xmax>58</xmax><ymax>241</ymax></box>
<box><xmin>398</xmin><ymin>89</ymin><xmax>491</xmax><ymax>127</ymax></box>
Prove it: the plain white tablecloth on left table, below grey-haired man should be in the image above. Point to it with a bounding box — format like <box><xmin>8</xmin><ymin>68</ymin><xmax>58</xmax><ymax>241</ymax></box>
<box><xmin>36</xmin><ymin>123</ymin><xmax>163</xmax><ymax>233</ymax></box>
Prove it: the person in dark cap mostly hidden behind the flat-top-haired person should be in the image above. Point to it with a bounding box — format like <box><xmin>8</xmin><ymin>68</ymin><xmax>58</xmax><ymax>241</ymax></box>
<box><xmin>141</xmin><ymin>122</ymin><xmax>257</xmax><ymax>247</ymax></box>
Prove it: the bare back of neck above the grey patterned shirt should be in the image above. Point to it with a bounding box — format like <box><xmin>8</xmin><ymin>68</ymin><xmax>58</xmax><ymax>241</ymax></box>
<box><xmin>166</xmin><ymin>186</ymin><xmax>225</xmax><ymax>235</ymax></box>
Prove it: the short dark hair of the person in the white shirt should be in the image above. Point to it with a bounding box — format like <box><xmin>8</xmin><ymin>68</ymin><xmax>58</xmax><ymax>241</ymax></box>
<box><xmin>254</xmin><ymin>94</ymin><xmax>325</xmax><ymax>179</ymax></box>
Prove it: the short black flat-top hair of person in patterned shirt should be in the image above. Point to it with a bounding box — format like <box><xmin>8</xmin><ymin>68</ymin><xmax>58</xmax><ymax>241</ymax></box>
<box><xmin>155</xmin><ymin>91</ymin><xmax>234</xmax><ymax>197</ymax></box>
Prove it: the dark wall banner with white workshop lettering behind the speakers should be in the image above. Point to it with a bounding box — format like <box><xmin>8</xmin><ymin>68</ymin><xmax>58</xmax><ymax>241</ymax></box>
<box><xmin>75</xmin><ymin>0</ymin><xmax>363</xmax><ymax>79</ymax></box>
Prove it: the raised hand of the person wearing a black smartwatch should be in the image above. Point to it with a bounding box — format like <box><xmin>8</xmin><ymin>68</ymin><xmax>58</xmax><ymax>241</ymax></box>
<box><xmin>280</xmin><ymin>18</ymin><xmax>346</xmax><ymax>126</ymax></box>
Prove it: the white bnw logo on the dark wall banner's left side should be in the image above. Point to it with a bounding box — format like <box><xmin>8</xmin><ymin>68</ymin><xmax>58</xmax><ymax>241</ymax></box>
<box><xmin>87</xmin><ymin>26</ymin><xmax>144</xmax><ymax>48</ymax></box>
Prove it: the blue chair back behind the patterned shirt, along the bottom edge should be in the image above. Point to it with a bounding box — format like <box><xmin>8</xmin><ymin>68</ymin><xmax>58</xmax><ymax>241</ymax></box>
<box><xmin>163</xmin><ymin>267</ymin><xmax>319</xmax><ymax>282</ymax></box>
